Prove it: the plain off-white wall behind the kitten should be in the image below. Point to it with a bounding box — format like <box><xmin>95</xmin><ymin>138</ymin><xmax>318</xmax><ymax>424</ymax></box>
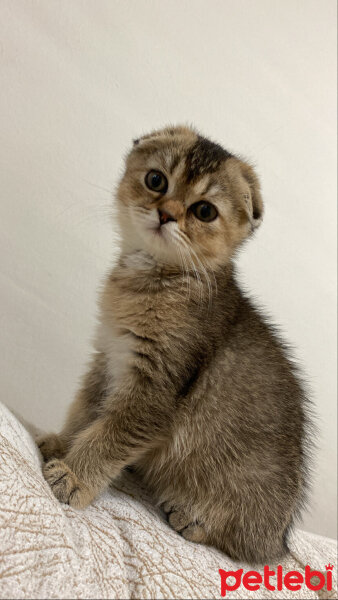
<box><xmin>0</xmin><ymin>0</ymin><xmax>336</xmax><ymax>537</ymax></box>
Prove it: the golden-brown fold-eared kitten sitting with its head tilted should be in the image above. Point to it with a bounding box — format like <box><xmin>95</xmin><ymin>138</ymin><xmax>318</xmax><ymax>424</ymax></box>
<box><xmin>39</xmin><ymin>127</ymin><xmax>307</xmax><ymax>562</ymax></box>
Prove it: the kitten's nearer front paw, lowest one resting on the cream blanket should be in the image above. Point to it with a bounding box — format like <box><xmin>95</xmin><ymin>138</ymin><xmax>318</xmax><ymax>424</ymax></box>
<box><xmin>43</xmin><ymin>459</ymin><xmax>95</xmax><ymax>508</ymax></box>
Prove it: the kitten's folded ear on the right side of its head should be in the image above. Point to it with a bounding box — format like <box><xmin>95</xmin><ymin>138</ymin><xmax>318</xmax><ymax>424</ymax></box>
<box><xmin>240</xmin><ymin>161</ymin><xmax>264</xmax><ymax>230</ymax></box>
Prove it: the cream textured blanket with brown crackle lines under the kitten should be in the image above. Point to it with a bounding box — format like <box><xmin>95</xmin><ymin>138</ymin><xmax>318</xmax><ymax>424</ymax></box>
<box><xmin>0</xmin><ymin>405</ymin><xmax>337</xmax><ymax>598</ymax></box>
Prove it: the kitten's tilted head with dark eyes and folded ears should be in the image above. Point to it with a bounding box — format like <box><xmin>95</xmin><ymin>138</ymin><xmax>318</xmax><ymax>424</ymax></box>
<box><xmin>117</xmin><ymin>127</ymin><xmax>263</xmax><ymax>269</ymax></box>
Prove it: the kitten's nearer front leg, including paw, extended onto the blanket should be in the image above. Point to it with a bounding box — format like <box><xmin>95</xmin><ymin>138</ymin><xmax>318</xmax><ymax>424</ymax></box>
<box><xmin>44</xmin><ymin>380</ymin><xmax>173</xmax><ymax>508</ymax></box>
